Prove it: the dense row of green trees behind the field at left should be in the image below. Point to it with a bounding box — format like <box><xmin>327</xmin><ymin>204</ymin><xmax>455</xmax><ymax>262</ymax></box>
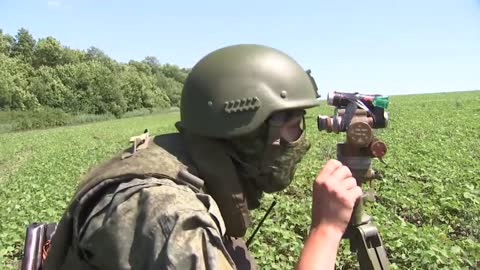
<box><xmin>0</xmin><ymin>28</ymin><xmax>189</xmax><ymax>117</ymax></box>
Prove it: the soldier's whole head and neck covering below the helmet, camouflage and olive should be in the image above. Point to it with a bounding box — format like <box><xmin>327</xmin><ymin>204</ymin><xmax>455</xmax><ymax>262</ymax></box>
<box><xmin>177</xmin><ymin>110</ymin><xmax>310</xmax><ymax>237</ymax></box>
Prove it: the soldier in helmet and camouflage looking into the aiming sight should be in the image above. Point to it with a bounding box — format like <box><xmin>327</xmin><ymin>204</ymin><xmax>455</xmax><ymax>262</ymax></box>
<box><xmin>44</xmin><ymin>45</ymin><xmax>361</xmax><ymax>270</ymax></box>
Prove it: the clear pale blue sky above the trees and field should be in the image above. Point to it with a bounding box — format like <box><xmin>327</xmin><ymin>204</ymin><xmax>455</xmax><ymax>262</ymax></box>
<box><xmin>0</xmin><ymin>0</ymin><xmax>480</xmax><ymax>97</ymax></box>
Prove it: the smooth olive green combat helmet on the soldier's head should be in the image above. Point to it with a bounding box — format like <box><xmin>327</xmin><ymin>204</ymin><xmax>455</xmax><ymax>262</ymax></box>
<box><xmin>180</xmin><ymin>45</ymin><xmax>319</xmax><ymax>138</ymax></box>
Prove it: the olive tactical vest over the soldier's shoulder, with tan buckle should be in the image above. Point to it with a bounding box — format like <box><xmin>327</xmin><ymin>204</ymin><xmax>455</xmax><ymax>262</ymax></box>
<box><xmin>44</xmin><ymin>134</ymin><xmax>251</xmax><ymax>269</ymax></box>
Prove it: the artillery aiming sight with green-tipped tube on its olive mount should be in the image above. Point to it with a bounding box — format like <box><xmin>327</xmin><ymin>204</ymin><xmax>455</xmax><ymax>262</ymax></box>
<box><xmin>317</xmin><ymin>92</ymin><xmax>390</xmax><ymax>270</ymax></box>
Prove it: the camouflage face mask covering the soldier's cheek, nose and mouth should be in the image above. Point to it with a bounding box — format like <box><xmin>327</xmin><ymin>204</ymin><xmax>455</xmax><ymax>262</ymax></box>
<box><xmin>233</xmin><ymin>109</ymin><xmax>310</xmax><ymax>202</ymax></box>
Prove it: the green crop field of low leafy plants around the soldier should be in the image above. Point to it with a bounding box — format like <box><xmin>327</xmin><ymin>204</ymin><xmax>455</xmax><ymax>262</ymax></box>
<box><xmin>0</xmin><ymin>91</ymin><xmax>480</xmax><ymax>269</ymax></box>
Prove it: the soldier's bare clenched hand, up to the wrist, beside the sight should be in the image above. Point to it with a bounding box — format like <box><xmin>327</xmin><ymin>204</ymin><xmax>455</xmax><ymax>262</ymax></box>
<box><xmin>312</xmin><ymin>159</ymin><xmax>362</xmax><ymax>236</ymax></box>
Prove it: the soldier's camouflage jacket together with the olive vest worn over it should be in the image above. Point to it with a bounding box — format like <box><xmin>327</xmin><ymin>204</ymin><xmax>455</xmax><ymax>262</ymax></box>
<box><xmin>44</xmin><ymin>134</ymin><xmax>255</xmax><ymax>270</ymax></box>
